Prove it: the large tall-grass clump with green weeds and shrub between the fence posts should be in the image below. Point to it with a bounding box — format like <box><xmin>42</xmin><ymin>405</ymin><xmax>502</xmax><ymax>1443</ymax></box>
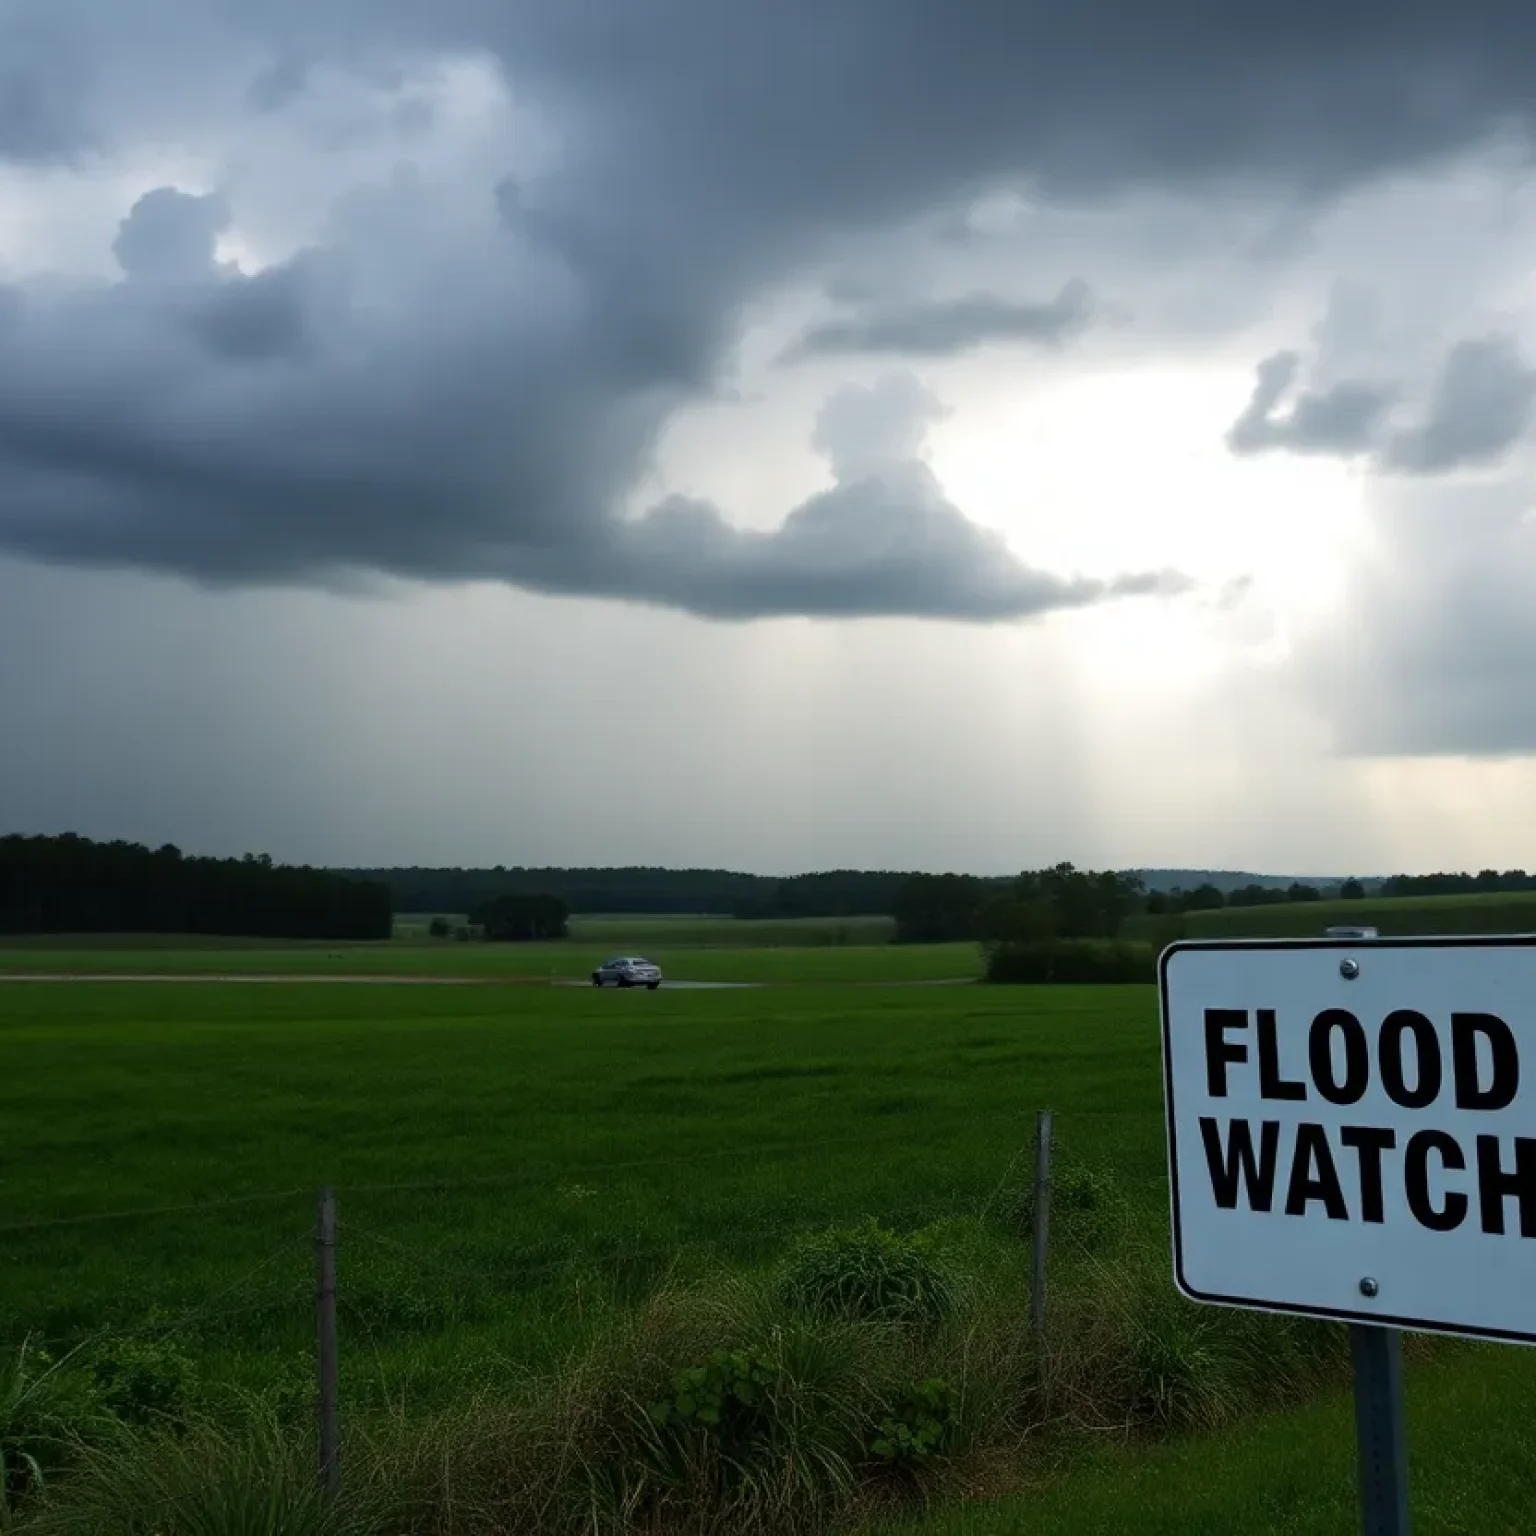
<box><xmin>384</xmin><ymin>1227</ymin><xmax>1028</xmax><ymax>1536</ymax></box>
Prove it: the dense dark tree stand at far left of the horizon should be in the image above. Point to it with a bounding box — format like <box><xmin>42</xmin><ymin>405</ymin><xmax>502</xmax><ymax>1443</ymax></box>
<box><xmin>0</xmin><ymin>833</ymin><xmax>393</xmax><ymax>938</ymax></box>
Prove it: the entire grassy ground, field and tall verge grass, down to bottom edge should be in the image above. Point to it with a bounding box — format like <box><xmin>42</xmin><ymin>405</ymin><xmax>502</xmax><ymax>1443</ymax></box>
<box><xmin>0</xmin><ymin>946</ymin><xmax>1536</xmax><ymax>1536</ymax></box>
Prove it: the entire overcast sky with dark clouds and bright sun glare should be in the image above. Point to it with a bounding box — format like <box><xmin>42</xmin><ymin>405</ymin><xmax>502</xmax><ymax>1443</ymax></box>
<box><xmin>0</xmin><ymin>0</ymin><xmax>1536</xmax><ymax>872</ymax></box>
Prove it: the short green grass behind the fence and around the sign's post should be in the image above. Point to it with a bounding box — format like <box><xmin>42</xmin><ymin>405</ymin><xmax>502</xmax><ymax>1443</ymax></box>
<box><xmin>0</xmin><ymin>940</ymin><xmax>1536</xmax><ymax>1536</ymax></box>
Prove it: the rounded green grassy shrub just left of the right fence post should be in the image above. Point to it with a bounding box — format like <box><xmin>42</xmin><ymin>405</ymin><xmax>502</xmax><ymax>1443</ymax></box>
<box><xmin>780</xmin><ymin>1218</ymin><xmax>955</xmax><ymax>1324</ymax></box>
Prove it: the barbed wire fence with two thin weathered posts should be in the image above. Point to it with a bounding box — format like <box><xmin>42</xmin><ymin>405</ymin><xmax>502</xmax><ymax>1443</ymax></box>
<box><xmin>0</xmin><ymin>1112</ymin><xmax>1054</xmax><ymax>1496</ymax></box>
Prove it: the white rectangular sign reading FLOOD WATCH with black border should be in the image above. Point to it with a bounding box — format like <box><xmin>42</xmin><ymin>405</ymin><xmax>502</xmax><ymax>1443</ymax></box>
<box><xmin>1161</xmin><ymin>937</ymin><xmax>1536</xmax><ymax>1342</ymax></box>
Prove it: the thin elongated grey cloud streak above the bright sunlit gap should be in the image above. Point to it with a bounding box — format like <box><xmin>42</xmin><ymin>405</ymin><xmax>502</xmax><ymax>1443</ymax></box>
<box><xmin>785</xmin><ymin>280</ymin><xmax>1094</xmax><ymax>361</ymax></box>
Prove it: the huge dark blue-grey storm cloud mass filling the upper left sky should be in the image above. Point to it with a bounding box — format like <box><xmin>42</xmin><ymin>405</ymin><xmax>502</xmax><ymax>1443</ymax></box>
<box><xmin>0</xmin><ymin>0</ymin><xmax>1536</xmax><ymax>617</ymax></box>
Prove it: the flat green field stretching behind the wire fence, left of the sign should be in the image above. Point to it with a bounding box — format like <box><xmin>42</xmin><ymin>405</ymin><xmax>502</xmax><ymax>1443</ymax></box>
<box><xmin>0</xmin><ymin>983</ymin><xmax>1160</xmax><ymax>1351</ymax></box>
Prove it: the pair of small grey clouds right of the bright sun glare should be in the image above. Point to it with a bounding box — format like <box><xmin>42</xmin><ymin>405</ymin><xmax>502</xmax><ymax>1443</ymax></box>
<box><xmin>1227</xmin><ymin>335</ymin><xmax>1536</xmax><ymax>475</ymax></box>
